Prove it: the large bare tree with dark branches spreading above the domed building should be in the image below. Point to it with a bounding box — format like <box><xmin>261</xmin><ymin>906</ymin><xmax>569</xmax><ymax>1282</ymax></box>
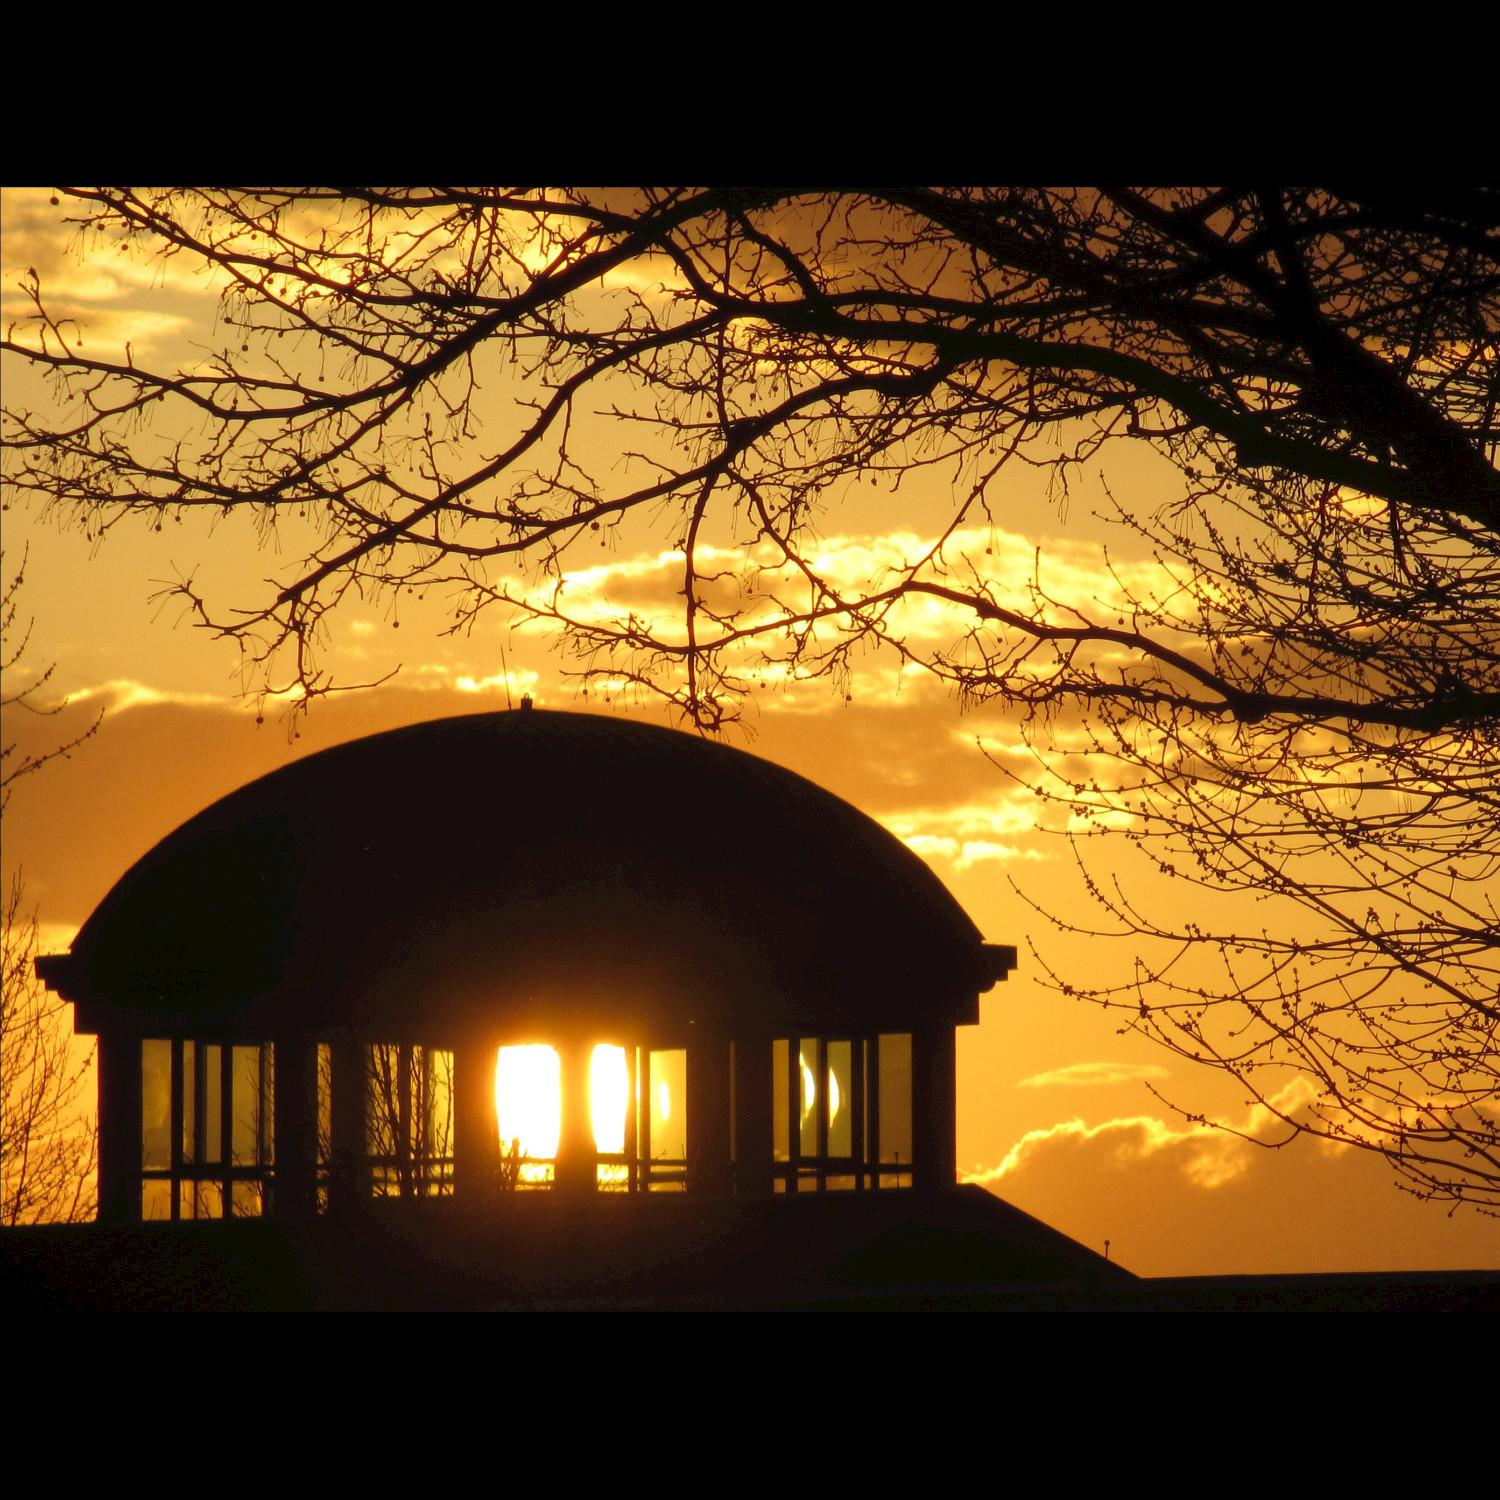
<box><xmin>5</xmin><ymin>188</ymin><xmax>1500</xmax><ymax>1209</ymax></box>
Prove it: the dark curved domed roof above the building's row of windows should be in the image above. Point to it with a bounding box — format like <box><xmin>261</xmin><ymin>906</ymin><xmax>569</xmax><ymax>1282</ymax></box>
<box><xmin>39</xmin><ymin>710</ymin><xmax>1013</xmax><ymax>1041</ymax></box>
